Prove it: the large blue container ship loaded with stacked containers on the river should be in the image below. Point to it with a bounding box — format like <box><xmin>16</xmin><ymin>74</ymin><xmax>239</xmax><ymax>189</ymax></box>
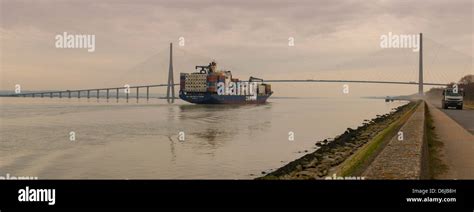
<box><xmin>179</xmin><ymin>61</ymin><xmax>273</xmax><ymax>104</ymax></box>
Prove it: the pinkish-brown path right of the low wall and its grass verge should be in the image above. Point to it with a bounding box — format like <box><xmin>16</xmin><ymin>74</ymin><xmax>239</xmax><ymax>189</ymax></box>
<box><xmin>428</xmin><ymin>104</ymin><xmax>474</xmax><ymax>179</ymax></box>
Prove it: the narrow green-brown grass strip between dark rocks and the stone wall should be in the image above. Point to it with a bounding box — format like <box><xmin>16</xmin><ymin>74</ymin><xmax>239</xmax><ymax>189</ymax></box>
<box><xmin>336</xmin><ymin>101</ymin><xmax>421</xmax><ymax>177</ymax></box>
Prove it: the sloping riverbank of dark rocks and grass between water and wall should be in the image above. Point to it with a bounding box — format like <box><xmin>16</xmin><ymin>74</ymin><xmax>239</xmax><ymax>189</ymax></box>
<box><xmin>257</xmin><ymin>102</ymin><xmax>418</xmax><ymax>179</ymax></box>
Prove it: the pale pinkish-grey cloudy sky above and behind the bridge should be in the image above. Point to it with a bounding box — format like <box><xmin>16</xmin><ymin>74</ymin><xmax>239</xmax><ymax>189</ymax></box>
<box><xmin>0</xmin><ymin>0</ymin><xmax>474</xmax><ymax>96</ymax></box>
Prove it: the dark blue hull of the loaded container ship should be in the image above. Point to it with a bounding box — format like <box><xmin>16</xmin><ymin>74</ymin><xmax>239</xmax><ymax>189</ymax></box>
<box><xmin>179</xmin><ymin>92</ymin><xmax>273</xmax><ymax>104</ymax></box>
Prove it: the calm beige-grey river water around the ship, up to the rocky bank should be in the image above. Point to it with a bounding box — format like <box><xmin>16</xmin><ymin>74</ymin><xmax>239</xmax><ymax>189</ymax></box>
<box><xmin>0</xmin><ymin>98</ymin><xmax>405</xmax><ymax>179</ymax></box>
